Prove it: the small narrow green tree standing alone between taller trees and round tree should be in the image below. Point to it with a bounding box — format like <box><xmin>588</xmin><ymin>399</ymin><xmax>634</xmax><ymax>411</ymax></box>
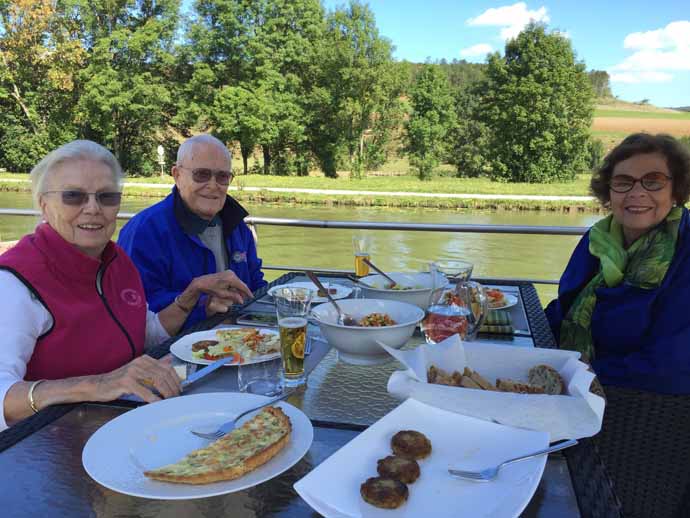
<box><xmin>406</xmin><ymin>65</ymin><xmax>454</xmax><ymax>180</ymax></box>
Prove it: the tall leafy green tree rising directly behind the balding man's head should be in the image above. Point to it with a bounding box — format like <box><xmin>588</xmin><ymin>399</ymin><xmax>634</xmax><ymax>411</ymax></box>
<box><xmin>183</xmin><ymin>0</ymin><xmax>323</xmax><ymax>174</ymax></box>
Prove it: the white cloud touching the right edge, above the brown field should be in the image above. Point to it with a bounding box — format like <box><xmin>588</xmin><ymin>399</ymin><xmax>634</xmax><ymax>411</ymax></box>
<box><xmin>610</xmin><ymin>20</ymin><xmax>690</xmax><ymax>83</ymax></box>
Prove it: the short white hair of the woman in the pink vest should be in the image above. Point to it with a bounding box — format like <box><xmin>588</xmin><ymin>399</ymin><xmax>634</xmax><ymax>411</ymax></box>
<box><xmin>30</xmin><ymin>140</ymin><xmax>124</xmax><ymax>207</ymax></box>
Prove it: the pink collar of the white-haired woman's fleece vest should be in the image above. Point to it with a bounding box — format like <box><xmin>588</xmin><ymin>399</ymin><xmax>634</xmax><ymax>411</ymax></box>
<box><xmin>34</xmin><ymin>223</ymin><xmax>117</xmax><ymax>282</ymax></box>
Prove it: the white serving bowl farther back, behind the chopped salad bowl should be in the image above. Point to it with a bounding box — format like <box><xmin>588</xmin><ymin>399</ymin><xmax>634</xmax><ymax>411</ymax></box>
<box><xmin>360</xmin><ymin>272</ymin><xmax>448</xmax><ymax>309</ymax></box>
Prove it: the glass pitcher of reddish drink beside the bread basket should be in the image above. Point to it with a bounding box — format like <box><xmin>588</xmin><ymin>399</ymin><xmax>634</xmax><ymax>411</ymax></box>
<box><xmin>421</xmin><ymin>281</ymin><xmax>488</xmax><ymax>344</ymax></box>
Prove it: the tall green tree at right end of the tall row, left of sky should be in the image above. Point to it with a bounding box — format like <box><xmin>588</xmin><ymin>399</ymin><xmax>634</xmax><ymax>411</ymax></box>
<box><xmin>308</xmin><ymin>1</ymin><xmax>402</xmax><ymax>178</ymax></box>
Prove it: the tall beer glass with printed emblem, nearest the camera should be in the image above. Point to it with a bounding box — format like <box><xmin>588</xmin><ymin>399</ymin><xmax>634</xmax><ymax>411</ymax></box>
<box><xmin>273</xmin><ymin>288</ymin><xmax>314</xmax><ymax>387</ymax></box>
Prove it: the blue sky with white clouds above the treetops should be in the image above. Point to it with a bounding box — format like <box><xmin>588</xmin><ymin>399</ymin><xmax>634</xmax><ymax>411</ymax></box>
<box><xmin>323</xmin><ymin>0</ymin><xmax>690</xmax><ymax>106</ymax></box>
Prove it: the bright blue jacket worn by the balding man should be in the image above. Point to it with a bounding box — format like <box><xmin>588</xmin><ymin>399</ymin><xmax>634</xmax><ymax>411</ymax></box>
<box><xmin>118</xmin><ymin>188</ymin><xmax>266</xmax><ymax>328</ymax></box>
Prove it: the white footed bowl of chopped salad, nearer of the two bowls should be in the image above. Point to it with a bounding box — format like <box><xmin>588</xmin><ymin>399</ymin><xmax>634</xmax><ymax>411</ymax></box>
<box><xmin>311</xmin><ymin>299</ymin><xmax>424</xmax><ymax>365</ymax></box>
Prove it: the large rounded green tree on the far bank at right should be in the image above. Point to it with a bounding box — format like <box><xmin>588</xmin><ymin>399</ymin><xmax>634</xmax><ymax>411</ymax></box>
<box><xmin>479</xmin><ymin>23</ymin><xmax>594</xmax><ymax>182</ymax></box>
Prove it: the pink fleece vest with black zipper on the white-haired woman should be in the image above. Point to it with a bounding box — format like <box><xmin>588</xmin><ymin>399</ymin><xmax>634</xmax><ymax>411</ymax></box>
<box><xmin>0</xmin><ymin>223</ymin><xmax>146</xmax><ymax>380</ymax></box>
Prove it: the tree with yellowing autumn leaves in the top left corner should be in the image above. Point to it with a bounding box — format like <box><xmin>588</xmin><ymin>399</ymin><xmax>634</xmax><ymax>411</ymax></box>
<box><xmin>0</xmin><ymin>0</ymin><xmax>85</xmax><ymax>171</ymax></box>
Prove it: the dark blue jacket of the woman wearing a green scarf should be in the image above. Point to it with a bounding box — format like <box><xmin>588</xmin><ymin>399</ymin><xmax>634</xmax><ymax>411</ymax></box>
<box><xmin>546</xmin><ymin>209</ymin><xmax>690</xmax><ymax>394</ymax></box>
